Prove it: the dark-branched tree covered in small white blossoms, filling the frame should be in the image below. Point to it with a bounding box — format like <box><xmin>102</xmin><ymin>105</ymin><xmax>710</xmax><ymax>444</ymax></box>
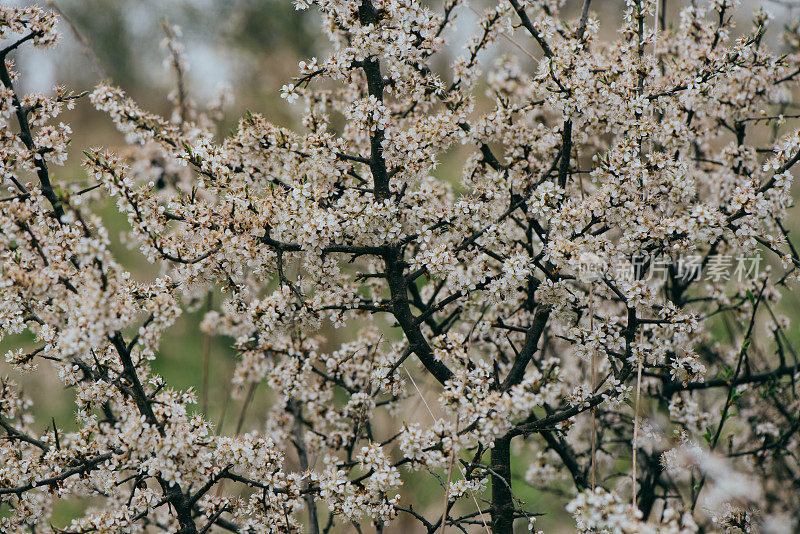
<box><xmin>0</xmin><ymin>0</ymin><xmax>800</xmax><ymax>534</ymax></box>
